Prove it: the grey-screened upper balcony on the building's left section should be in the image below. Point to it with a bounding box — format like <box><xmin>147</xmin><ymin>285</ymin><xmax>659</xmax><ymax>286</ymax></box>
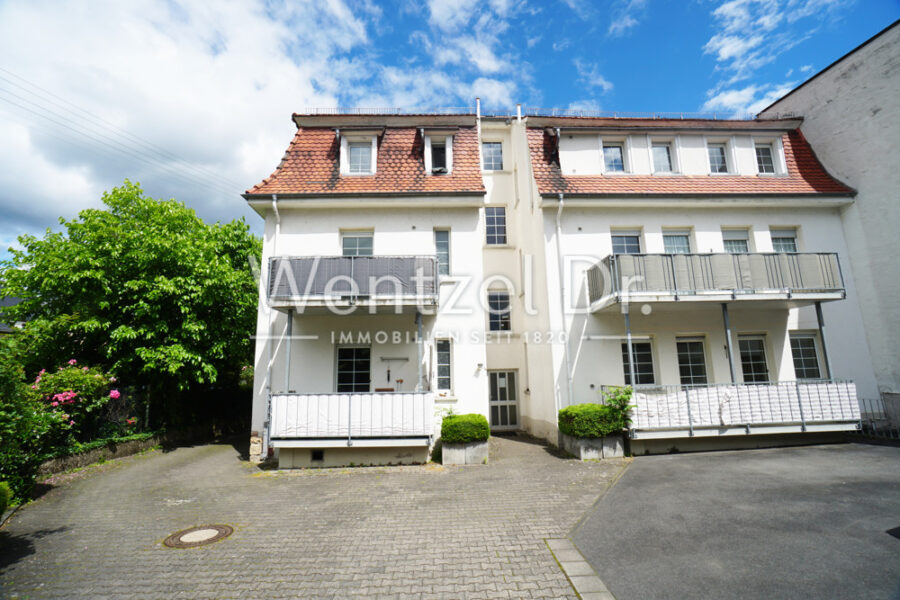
<box><xmin>268</xmin><ymin>256</ymin><xmax>438</xmax><ymax>309</ymax></box>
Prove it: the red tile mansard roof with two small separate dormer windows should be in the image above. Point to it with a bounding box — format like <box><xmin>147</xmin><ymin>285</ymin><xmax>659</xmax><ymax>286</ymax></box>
<box><xmin>245</xmin><ymin>127</ymin><xmax>484</xmax><ymax>196</ymax></box>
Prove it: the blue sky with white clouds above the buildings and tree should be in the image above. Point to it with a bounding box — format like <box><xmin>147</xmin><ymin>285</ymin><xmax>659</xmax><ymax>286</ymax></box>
<box><xmin>0</xmin><ymin>0</ymin><xmax>900</xmax><ymax>258</ymax></box>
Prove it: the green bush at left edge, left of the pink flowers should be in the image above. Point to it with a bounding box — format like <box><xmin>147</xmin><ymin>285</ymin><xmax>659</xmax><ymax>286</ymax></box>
<box><xmin>0</xmin><ymin>335</ymin><xmax>65</xmax><ymax>499</ymax></box>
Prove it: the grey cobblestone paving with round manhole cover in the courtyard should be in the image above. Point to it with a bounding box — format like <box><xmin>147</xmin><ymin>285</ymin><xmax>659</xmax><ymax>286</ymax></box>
<box><xmin>0</xmin><ymin>437</ymin><xmax>625</xmax><ymax>599</ymax></box>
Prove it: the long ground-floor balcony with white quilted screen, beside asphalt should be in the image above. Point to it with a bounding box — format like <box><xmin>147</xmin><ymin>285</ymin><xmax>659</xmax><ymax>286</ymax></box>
<box><xmin>630</xmin><ymin>380</ymin><xmax>860</xmax><ymax>439</ymax></box>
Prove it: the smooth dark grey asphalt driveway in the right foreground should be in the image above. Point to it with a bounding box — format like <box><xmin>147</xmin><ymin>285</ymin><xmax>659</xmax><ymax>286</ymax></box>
<box><xmin>574</xmin><ymin>444</ymin><xmax>900</xmax><ymax>600</ymax></box>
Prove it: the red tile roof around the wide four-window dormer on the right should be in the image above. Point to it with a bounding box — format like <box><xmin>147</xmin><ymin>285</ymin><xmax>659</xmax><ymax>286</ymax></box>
<box><xmin>528</xmin><ymin>128</ymin><xmax>855</xmax><ymax>196</ymax></box>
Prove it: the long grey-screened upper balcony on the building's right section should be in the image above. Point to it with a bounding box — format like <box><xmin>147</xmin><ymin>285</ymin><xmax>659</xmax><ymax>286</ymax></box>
<box><xmin>587</xmin><ymin>252</ymin><xmax>846</xmax><ymax>312</ymax></box>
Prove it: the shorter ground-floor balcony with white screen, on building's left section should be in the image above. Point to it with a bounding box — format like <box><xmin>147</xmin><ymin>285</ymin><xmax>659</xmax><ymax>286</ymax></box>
<box><xmin>269</xmin><ymin>392</ymin><xmax>434</xmax><ymax>448</ymax></box>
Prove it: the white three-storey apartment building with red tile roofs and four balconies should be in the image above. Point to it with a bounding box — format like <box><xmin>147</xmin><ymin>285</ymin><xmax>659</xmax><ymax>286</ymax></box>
<box><xmin>244</xmin><ymin>101</ymin><xmax>877</xmax><ymax>467</ymax></box>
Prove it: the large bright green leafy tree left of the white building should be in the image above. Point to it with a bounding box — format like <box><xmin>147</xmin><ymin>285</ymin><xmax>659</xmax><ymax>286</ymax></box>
<box><xmin>0</xmin><ymin>180</ymin><xmax>262</xmax><ymax>424</ymax></box>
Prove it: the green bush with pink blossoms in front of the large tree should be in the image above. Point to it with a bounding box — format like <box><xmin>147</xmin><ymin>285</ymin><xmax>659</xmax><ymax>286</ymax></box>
<box><xmin>31</xmin><ymin>358</ymin><xmax>121</xmax><ymax>441</ymax></box>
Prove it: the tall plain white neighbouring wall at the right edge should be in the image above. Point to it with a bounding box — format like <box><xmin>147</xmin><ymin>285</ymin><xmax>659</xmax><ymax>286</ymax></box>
<box><xmin>759</xmin><ymin>21</ymin><xmax>900</xmax><ymax>403</ymax></box>
